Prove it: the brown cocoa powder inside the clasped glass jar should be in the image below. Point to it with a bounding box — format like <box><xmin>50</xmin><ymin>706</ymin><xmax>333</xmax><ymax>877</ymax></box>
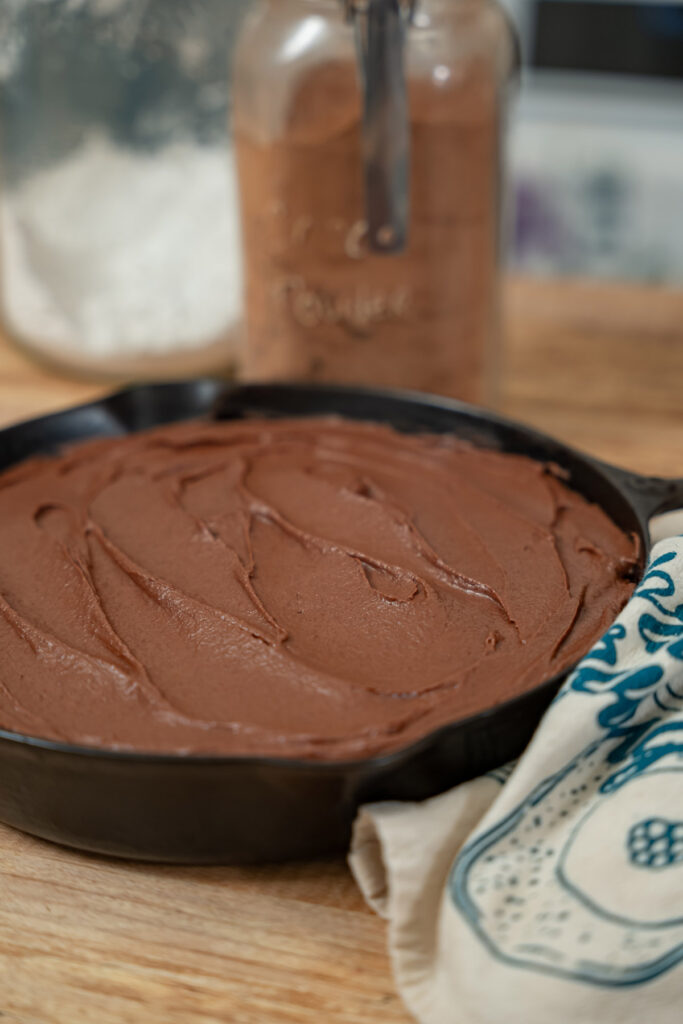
<box><xmin>234</xmin><ymin>57</ymin><xmax>499</xmax><ymax>401</ymax></box>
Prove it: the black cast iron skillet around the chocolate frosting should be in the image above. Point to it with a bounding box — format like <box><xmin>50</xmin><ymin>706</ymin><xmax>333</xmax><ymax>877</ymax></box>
<box><xmin>0</xmin><ymin>380</ymin><xmax>683</xmax><ymax>863</ymax></box>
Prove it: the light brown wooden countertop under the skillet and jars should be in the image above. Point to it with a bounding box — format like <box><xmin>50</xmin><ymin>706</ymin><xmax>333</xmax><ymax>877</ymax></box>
<box><xmin>0</xmin><ymin>281</ymin><xmax>683</xmax><ymax>1024</ymax></box>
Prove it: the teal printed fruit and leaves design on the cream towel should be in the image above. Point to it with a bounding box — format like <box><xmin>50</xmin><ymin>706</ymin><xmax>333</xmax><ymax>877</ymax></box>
<box><xmin>450</xmin><ymin>551</ymin><xmax>683</xmax><ymax>986</ymax></box>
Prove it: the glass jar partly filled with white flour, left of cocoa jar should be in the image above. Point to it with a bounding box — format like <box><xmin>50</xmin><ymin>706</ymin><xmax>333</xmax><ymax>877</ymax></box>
<box><xmin>0</xmin><ymin>0</ymin><xmax>248</xmax><ymax>378</ymax></box>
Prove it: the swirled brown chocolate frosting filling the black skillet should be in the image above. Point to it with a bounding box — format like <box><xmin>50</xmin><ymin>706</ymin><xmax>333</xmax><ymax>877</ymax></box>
<box><xmin>0</xmin><ymin>419</ymin><xmax>637</xmax><ymax>759</ymax></box>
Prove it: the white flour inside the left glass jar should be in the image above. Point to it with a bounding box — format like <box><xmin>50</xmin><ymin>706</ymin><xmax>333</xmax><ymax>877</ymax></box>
<box><xmin>1</xmin><ymin>134</ymin><xmax>242</xmax><ymax>369</ymax></box>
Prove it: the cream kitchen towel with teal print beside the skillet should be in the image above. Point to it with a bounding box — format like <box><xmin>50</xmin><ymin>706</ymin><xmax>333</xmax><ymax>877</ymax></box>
<box><xmin>349</xmin><ymin>538</ymin><xmax>683</xmax><ymax>1024</ymax></box>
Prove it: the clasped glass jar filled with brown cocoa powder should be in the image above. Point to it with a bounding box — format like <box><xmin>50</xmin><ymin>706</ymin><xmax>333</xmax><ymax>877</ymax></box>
<box><xmin>232</xmin><ymin>0</ymin><xmax>516</xmax><ymax>401</ymax></box>
